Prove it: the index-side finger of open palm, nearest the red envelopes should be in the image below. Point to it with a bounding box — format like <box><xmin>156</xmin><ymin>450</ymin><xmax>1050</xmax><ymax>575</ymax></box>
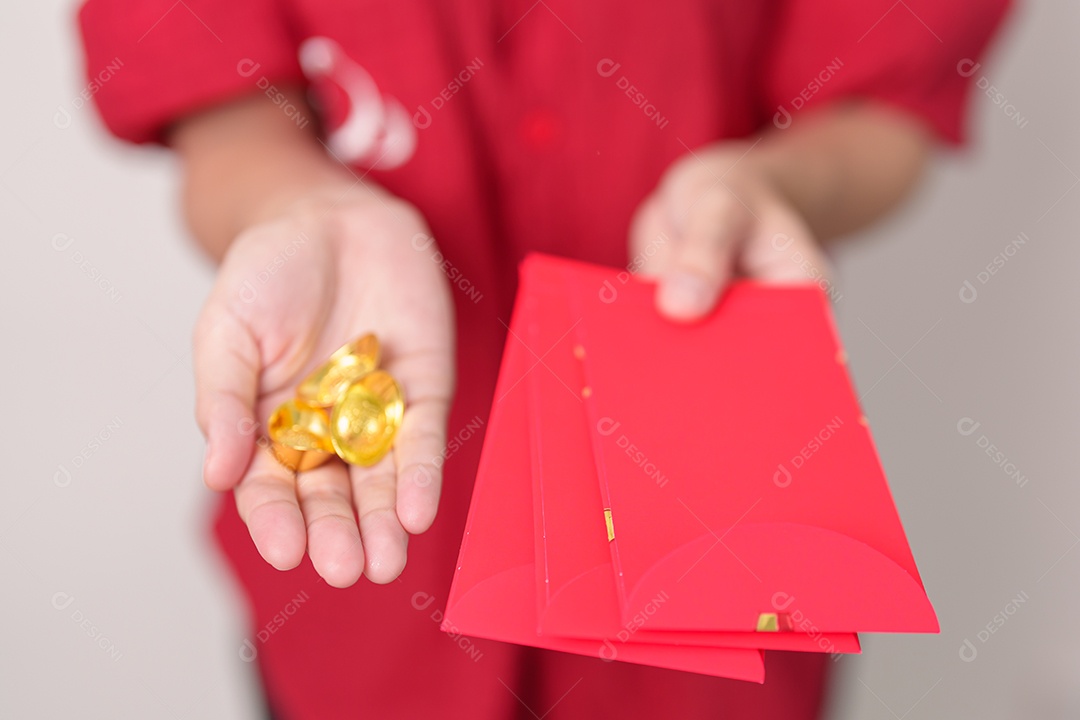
<box><xmin>394</xmin><ymin>397</ymin><xmax>449</xmax><ymax>534</ymax></box>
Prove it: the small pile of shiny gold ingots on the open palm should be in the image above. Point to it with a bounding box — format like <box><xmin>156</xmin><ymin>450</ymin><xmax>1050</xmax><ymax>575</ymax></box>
<box><xmin>267</xmin><ymin>335</ymin><xmax>405</xmax><ymax>472</ymax></box>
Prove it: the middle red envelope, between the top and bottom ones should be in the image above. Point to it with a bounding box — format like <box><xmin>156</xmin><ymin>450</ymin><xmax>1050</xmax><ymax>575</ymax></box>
<box><xmin>526</xmin><ymin>275</ymin><xmax>860</xmax><ymax>653</ymax></box>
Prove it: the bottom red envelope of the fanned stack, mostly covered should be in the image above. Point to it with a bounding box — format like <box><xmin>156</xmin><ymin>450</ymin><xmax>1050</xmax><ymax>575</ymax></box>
<box><xmin>442</xmin><ymin>279</ymin><xmax>765</xmax><ymax>682</ymax></box>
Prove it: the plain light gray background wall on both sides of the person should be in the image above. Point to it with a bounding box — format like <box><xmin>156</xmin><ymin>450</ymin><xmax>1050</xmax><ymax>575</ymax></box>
<box><xmin>0</xmin><ymin>0</ymin><xmax>1080</xmax><ymax>720</ymax></box>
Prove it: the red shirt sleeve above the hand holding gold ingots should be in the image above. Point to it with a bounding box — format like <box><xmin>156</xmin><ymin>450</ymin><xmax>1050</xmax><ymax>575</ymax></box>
<box><xmin>79</xmin><ymin>0</ymin><xmax>303</xmax><ymax>142</ymax></box>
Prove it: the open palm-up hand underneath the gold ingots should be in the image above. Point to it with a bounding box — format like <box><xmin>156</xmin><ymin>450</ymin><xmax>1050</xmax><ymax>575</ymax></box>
<box><xmin>194</xmin><ymin>187</ymin><xmax>454</xmax><ymax>587</ymax></box>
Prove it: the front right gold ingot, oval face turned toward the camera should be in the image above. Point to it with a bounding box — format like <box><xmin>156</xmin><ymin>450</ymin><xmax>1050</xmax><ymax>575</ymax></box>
<box><xmin>330</xmin><ymin>370</ymin><xmax>405</xmax><ymax>466</ymax></box>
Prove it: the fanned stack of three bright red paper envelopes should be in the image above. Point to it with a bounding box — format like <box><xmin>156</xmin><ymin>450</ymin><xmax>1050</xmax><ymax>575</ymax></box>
<box><xmin>443</xmin><ymin>255</ymin><xmax>937</xmax><ymax>682</ymax></box>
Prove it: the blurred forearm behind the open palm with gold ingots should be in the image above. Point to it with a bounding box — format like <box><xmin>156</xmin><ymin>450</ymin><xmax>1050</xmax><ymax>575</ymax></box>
<box><xmin>170</xmin><ymin>91</ymin><xmax>355</xmax><ymax>260</ymax></box>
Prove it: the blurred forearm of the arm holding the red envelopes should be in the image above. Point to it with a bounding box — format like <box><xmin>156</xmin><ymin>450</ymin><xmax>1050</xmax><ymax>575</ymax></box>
<box><xmin>747</xmin><ymin>103</ymin><xmax>932</xmax><ymax>241</ymax></box>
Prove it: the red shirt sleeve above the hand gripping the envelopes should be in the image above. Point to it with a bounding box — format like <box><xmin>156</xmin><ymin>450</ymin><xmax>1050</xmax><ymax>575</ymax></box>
<box><xmin>764</xmin><ymin>0</ymin><xmax>1010</xmax><ymax>145</ymax></box>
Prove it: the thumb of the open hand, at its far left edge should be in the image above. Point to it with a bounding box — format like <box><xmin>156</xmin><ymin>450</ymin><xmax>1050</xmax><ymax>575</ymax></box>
<box><xmin>193</xmin><ymin>300</ymin><xmax>259</xmax><ymax>490</ymax></box>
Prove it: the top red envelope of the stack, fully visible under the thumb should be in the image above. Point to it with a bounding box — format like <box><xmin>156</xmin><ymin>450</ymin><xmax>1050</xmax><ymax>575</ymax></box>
<box><xmin>524</xmin><ymin>256</ymin><xmax>939</xmax><ymax>635</ymax></box>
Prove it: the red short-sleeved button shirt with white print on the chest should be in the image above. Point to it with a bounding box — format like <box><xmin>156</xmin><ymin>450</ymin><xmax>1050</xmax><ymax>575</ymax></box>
<box><xmin>80</xmin><ymin>0</ymin><xmax>1008</xmax><ymax>720</ymax></box>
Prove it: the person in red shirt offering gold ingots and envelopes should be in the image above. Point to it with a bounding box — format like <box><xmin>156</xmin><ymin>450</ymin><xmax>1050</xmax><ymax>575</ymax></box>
<box><xmin>79</xmin><ymin>0</ymin><xmax>1007</xmax><ymax>720</ymax></box>
